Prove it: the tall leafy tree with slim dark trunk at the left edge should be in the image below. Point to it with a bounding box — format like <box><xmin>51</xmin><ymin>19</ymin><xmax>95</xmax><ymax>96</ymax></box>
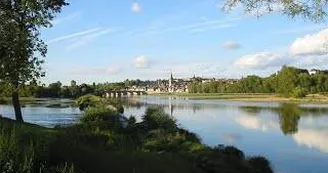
<box><xmin>0</xmin><ymin>0</ymin><xmax>68</xmax><ymax>121</ymax></box>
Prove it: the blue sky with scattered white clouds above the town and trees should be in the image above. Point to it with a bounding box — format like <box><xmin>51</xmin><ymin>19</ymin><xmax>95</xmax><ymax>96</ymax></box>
<box><xmin>42</xmin><ymin>0</ymin><xmax>328</xmax><ymax>84</ymax></box>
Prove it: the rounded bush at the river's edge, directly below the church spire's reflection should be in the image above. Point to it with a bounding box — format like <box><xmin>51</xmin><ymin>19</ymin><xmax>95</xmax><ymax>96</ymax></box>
<box><xmin>142</xmin><ymin>107</ymin><xmax>177</xmax><ymax>131</ymax></box>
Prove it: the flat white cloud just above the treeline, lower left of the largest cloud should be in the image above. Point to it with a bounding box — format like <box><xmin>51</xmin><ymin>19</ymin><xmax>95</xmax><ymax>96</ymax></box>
<box><xmin>234</xmin><ymin>52</ymin><xmax>287</xmax><ymax>69</ymax></box>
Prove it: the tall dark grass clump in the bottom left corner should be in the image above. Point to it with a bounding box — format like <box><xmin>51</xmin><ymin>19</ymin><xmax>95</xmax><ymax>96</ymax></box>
<box><xmin>0</xmin><ymin>128</ymin><xmax>74</xmax><ymax>173</ymax></box>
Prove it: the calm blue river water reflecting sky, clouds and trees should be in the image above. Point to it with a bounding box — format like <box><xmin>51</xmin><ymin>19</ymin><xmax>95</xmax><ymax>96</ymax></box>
<box><xmin>0</xmin><ymin>96</ymin><xmax>328</xmax><ymax>173</ymax></box>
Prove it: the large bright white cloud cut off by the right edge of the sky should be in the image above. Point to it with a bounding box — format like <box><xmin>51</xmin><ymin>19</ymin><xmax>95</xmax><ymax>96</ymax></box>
<box><xmin>290</xmin><ymin>28</ymin><xmax>328</xmax><ymax>56</ymax></box>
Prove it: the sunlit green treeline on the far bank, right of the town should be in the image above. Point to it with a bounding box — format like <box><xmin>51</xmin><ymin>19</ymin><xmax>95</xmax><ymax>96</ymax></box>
<box><xmin>188</xmin><ymin>66</ymin><xmax>328</xmax><ymax>97</ymax></box>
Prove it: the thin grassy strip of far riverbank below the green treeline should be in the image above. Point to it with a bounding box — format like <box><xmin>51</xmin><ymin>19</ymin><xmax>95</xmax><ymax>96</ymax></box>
<box><xmin>150</xmin><ymin>93</ymin><xmax>328</xmax><ymax>104</ymax></box>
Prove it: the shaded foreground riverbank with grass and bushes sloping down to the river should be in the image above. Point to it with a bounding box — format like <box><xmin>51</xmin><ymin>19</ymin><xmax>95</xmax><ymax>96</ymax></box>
<box><xmin>0</xmin><ymin>96</ymin><xmax>272</xmax><ymax>173</ymax></box>
